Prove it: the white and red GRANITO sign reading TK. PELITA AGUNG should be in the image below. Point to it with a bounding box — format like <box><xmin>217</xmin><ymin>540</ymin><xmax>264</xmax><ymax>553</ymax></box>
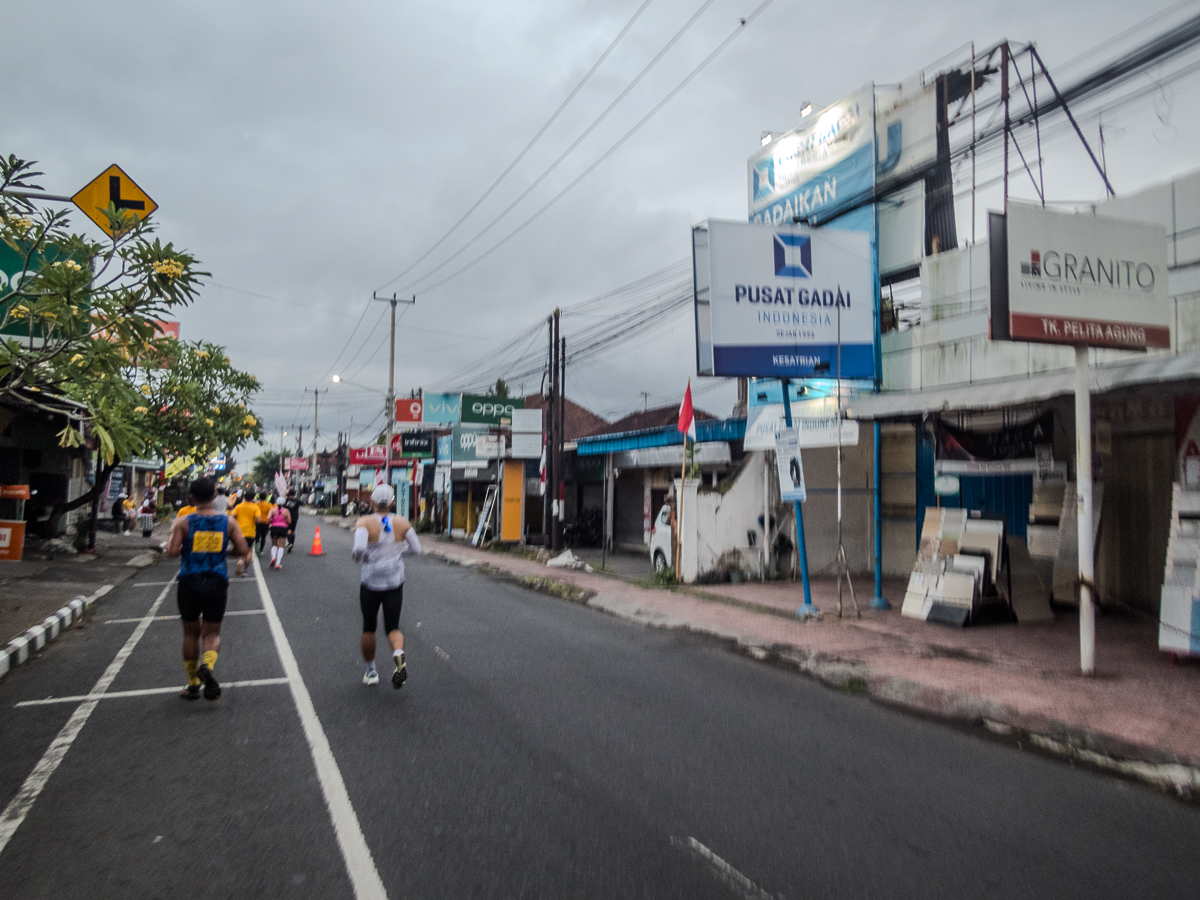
<box><xmin>988</xmin><ymin>203</ymin><xmax>1172</xmax><ymax>350</ymax></box>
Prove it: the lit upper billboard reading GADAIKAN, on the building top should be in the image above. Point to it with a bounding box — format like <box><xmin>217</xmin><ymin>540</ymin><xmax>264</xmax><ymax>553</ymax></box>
<box><xmin>748</xmin><ymin>84</ymin><xmax>875</xmax><ymax>224</ymax></box>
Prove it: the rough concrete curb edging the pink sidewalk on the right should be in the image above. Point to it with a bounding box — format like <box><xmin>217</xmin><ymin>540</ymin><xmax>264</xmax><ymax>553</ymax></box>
<box><xmin>424</xmin><ymin>548</ymin><xmax>1200</xmax><ymax>802</ymax></box>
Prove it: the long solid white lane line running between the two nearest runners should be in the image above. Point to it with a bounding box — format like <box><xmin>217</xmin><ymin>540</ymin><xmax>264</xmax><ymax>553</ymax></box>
<box><xmin>254</xmin><ymin>557</ymin><xmax>388</xmax><ymax>900</ymax></box>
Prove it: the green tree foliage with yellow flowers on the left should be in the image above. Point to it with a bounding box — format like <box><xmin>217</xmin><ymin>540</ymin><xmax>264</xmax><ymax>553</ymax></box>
<box><xmin>0</xmin><ymin>156</ymin><xmax>262</xmax><ymax>525</ymax></box>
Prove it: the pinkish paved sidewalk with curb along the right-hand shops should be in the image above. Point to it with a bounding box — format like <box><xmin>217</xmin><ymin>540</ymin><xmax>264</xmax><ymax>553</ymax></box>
<box><xmin>421</xmin><ymin>535</ymin><xmax>1200</xmax><ymax>797</ymax></box>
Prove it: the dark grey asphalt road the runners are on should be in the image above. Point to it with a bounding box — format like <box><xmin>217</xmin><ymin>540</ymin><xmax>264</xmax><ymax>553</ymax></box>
<box><xmin>0</xmin><ymin>517</ymin><xmax>1200</xmax><ymax>900</ymax></box>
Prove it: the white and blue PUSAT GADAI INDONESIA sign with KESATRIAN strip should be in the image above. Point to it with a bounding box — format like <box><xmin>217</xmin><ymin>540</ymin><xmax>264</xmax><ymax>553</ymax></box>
<box><xmin>692</xmin><ymin>220</ymin><xmax>875</xmax><ymax>378</ymax></box>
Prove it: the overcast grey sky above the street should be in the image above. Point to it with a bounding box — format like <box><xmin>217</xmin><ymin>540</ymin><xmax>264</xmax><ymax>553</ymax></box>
<box><xmin>9</xmin><ymin>0</ymin><xmax>1200</xmax><ymax>465</ymax></box>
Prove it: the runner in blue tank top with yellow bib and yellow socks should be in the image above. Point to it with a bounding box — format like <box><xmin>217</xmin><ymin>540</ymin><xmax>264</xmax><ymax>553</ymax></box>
<box><xmin>167</xmin><ymin>478</ymin><xmax>250</xmax><ymax>700</ymax></box>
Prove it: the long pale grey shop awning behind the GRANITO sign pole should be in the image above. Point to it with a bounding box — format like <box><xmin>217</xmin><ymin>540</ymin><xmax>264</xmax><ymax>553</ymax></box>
<box><xmin>846</xmin><ymin>353</ymin><xmax>1200</xmax><ymax>419</ymax></box>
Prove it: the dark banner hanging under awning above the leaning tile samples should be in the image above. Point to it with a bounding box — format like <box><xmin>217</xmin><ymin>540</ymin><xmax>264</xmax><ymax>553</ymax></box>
<box><xmin>934</xmin><ymin>410</ymin><xmax>1054</xmax><ymax>475</ymax></box>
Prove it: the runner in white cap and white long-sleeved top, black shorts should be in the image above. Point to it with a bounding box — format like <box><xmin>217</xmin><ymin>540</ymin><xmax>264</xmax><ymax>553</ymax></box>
<box><xmin>353</xmin><ymin>485</ymin><xmax>421</xmax><ymax>689</ymax></box>
